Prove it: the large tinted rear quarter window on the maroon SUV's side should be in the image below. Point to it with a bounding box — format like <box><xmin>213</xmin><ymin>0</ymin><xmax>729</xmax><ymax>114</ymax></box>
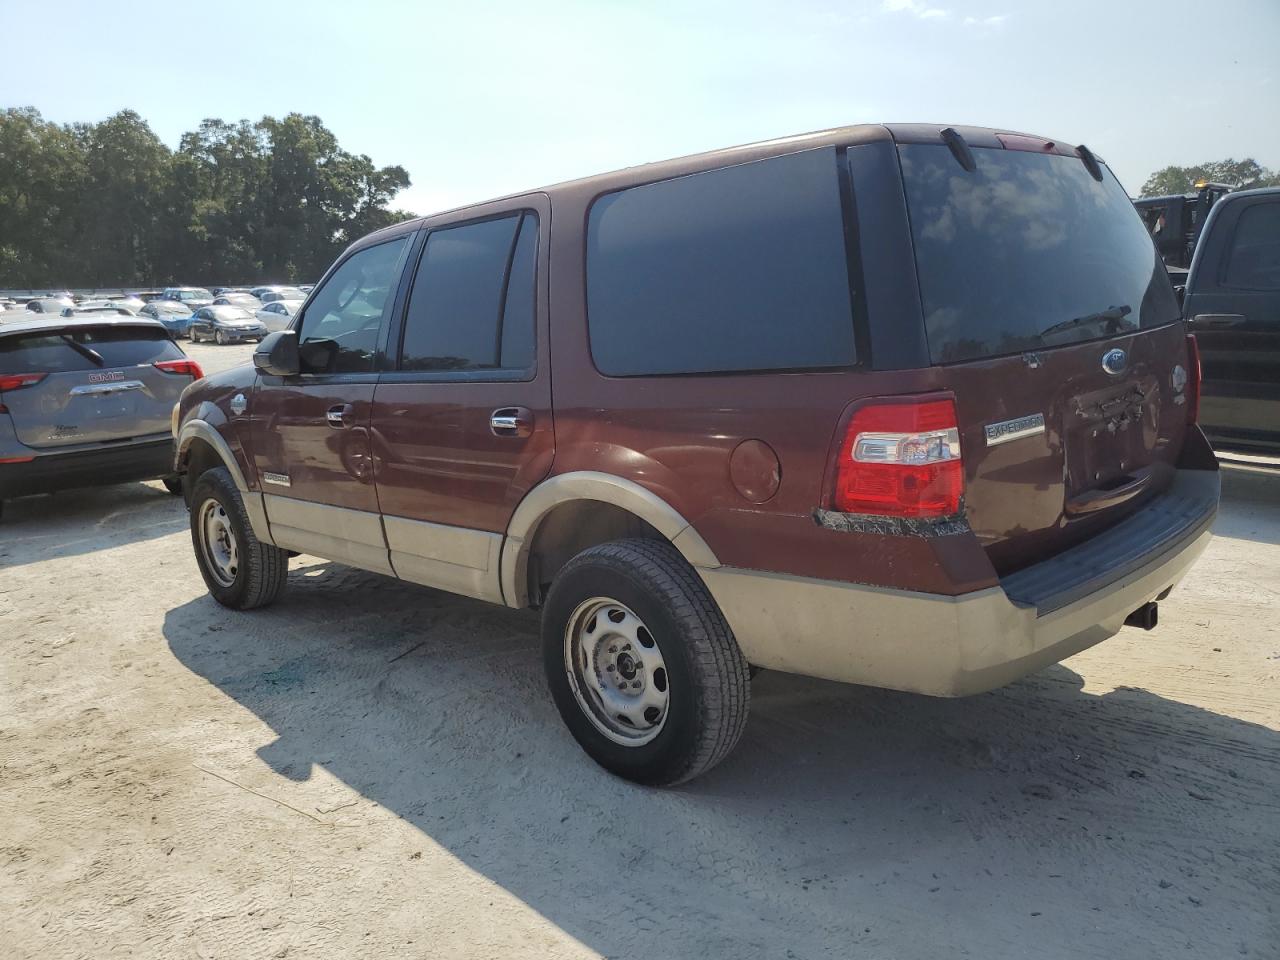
<box><xmin>586</xmin><ymin>147</ymin><xmax>854</xmax><ymax>376</ymax></box>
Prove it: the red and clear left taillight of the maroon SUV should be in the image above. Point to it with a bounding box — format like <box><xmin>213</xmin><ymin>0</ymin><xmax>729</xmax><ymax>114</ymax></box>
<box><xmin>832</xmin><ymin>399</ymin><xmax>964</xmax><ymax>517</ymax></box>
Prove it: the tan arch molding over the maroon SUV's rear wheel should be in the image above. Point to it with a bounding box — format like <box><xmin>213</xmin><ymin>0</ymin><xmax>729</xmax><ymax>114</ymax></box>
<box><xmin>502</xmin><ymin>470</ymin><xmax>721</xmax><ymax>609</ymax></box>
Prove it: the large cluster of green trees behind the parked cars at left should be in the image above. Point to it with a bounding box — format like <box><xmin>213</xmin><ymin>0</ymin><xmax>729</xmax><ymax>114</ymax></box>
<box><xmin>0</xmin><ymin>108</ymin><xmax>411</xmax><ymax>288</ymax></box>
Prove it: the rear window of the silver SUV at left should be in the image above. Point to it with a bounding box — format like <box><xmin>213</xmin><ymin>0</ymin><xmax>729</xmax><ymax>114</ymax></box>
<box><xmin>0</xmin><ymin>326</ymin><xmax>184</xmax><ymax>374</ymax></box>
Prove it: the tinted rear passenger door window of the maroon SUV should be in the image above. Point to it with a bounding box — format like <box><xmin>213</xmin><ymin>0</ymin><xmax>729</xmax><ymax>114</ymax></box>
<box><xmin>401</xmin><ymin>214</ymin><xmax>538</xmax><ymax>370</ymax></box>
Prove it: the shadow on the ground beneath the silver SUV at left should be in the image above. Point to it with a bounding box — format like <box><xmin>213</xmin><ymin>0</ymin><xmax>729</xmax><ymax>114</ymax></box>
<box><xmin>0</xmin><ymin>481</ymin><xmax>187</xmax><ymax>567</ymax></box>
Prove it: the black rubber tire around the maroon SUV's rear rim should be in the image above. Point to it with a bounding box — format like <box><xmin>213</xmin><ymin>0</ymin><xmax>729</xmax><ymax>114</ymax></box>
<box><xmin>541</xmin><ymin>540</ymin><xmax>751</xmax><ymax>786</ymax></box>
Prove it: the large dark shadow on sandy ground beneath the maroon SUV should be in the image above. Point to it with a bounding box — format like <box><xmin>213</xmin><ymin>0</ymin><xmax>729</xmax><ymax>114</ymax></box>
<box><xmin>164</xmin><ymin>564</ymin><xmax>1280</xmax><ymax>957</ymax></box>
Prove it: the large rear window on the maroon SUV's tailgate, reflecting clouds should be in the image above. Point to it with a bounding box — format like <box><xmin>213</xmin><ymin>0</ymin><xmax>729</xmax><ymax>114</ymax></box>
<box><xmin>899</xmin><ymin>143</ymin><xmax>1179</xmax><ymax>364</ymax></box>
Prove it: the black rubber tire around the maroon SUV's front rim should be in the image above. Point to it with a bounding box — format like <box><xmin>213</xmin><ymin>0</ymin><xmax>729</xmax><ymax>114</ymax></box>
<box><xmin>191</xmin><ymin>467</ymin><xmax>289</xmax><ymax>611</ymax></box>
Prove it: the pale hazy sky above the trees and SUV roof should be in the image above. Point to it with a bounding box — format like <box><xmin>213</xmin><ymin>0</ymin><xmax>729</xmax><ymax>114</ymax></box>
<box><xmin>0</xmin><ymin>0</ymin><xmax>1280</xmax><ymax>214</ymax></box>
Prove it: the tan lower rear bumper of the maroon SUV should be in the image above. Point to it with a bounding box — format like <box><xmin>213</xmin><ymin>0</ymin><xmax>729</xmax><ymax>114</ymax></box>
<box><xmin>698</xmin><ymin>531</ymin><xmax>1210</xmax><ymax>696</ymax></box>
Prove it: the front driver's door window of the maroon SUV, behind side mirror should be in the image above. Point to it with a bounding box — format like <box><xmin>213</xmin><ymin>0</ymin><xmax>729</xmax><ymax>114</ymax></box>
<box><xmin>298</xmin><ymin>234</ymin><xmax>410</xmax><ymax>374</ymax></box>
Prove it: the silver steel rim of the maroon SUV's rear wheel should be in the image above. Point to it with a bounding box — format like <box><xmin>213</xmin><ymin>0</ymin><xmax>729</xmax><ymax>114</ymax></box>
<box><xmin>564</xmin><ymin>596</ymin><xmax>671</xmax><ymax>746</ymax></box>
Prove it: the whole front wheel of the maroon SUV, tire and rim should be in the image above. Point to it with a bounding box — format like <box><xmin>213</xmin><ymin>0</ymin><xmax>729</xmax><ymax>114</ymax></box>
<box><xmin>191</xmin><ymin>467</ymin><xmax>289</xmax><ymax>611</ymax></box>
